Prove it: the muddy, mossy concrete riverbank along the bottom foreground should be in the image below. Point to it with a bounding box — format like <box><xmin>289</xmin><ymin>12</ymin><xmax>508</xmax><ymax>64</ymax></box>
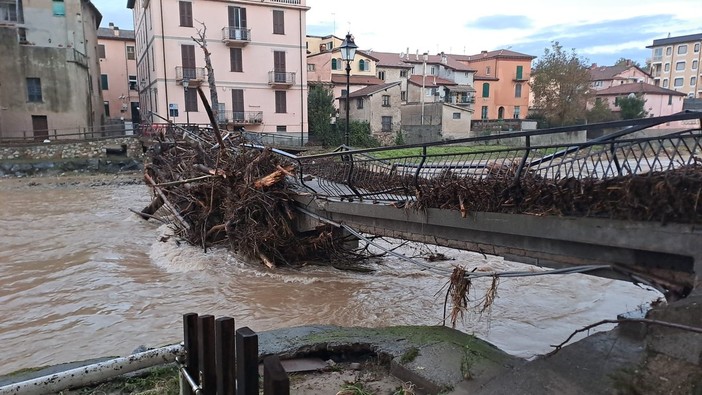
<box><xmin>0</xmin><ymin>326</ymin><xmax>702</xmax><ymax>395</ymax></box>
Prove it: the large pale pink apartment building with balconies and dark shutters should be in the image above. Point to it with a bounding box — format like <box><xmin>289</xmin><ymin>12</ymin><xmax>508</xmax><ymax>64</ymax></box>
<box><xmin>127</xmin><ymin>0</ymin><xmax>309</xmax><ymax>138</ymax></box>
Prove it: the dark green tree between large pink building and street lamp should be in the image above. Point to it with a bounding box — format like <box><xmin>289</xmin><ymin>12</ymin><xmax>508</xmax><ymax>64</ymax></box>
<box><xmin>307</xmin><ymin>85</ymin><xmax>341</xmax><ymax>147</ymax></box>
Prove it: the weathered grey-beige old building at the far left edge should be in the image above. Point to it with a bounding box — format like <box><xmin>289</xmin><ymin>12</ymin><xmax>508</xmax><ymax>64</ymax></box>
<box><xmin>0</xmin><ymin>0</ymin><xmax>104</xmax><ymax>140</ymax></box>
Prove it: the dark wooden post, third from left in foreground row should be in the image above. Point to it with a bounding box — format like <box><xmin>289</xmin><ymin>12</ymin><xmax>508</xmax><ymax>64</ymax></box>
<box><xmin>215</xmin><ymin>317</ymin><xmax>236</xmax><ymax>395</ymax></box>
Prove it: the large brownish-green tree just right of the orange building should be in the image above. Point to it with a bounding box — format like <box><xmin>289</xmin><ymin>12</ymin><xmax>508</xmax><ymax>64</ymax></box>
<box><xmin>530</xmin><ymin>41</ymin><xmax>592</xmax><ymax>126</ymax></box>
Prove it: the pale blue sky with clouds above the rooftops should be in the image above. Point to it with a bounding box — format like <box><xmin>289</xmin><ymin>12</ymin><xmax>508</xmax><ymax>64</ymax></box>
<box><xmin>92</xmin><ymin>0</ymin><xmax>702</xmax><ymax>66</ymax></box>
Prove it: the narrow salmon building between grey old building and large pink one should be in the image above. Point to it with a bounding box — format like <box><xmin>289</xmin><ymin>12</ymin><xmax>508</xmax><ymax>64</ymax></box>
<box><xmin>98</xmin><ymin>23</ymin><xmax>140</xmax><ymax>129</ymax></box>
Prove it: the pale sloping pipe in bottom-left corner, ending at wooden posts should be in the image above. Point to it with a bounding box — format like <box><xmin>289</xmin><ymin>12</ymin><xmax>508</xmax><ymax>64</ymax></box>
<box><xmin>0</xmin><ymin>344</ymin><xmax>185</xmax><ymax>395</ymax></box>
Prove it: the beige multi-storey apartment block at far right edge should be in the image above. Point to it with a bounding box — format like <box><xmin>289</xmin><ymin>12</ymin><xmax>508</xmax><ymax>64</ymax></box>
<box><xmin>646</xmin><ymin>33</ymin><xmax>702</xmax><ymax>99</ymax></box>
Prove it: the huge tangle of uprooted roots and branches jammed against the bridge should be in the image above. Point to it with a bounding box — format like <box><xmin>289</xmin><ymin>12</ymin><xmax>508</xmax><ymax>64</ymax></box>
<box><xmin>143</xmin><ymin>131</ymin><xmax>374</xmax><ymax>268</ymax></box>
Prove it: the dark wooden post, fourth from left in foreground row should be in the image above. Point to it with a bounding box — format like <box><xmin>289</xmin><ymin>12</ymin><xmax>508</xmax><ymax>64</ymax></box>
<box><xmin>236</xmin><ymin>326</ymin><xmax>258</xmax><ymax>395</ymax></box>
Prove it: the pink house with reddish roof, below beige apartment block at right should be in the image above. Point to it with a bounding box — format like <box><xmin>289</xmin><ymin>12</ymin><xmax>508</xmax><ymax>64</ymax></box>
<box><xmin>596</xmin><ymin>82</ymin><xmax>689</xmax><ymax>128</ymax></box>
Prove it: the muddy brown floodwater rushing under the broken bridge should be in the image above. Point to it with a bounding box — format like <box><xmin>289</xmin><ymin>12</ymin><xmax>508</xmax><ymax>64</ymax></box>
<box><xmin>0</xmin><ymin>176</ymin><xmax>660</xmax><ymax>374</ymax></box>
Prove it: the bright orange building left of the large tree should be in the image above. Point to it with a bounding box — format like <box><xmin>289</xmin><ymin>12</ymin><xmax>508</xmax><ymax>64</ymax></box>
<box><xmin>449</xmin><ymin>49</ymin><xmax>536</xmax><ymax>119</ymax></box>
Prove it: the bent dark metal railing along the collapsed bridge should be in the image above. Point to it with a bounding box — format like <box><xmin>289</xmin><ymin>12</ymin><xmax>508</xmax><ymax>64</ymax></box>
<box><xmin>288</xmin><ymin>112</ymin><xmax>702</xmax><ymax>201</ymax></box>
